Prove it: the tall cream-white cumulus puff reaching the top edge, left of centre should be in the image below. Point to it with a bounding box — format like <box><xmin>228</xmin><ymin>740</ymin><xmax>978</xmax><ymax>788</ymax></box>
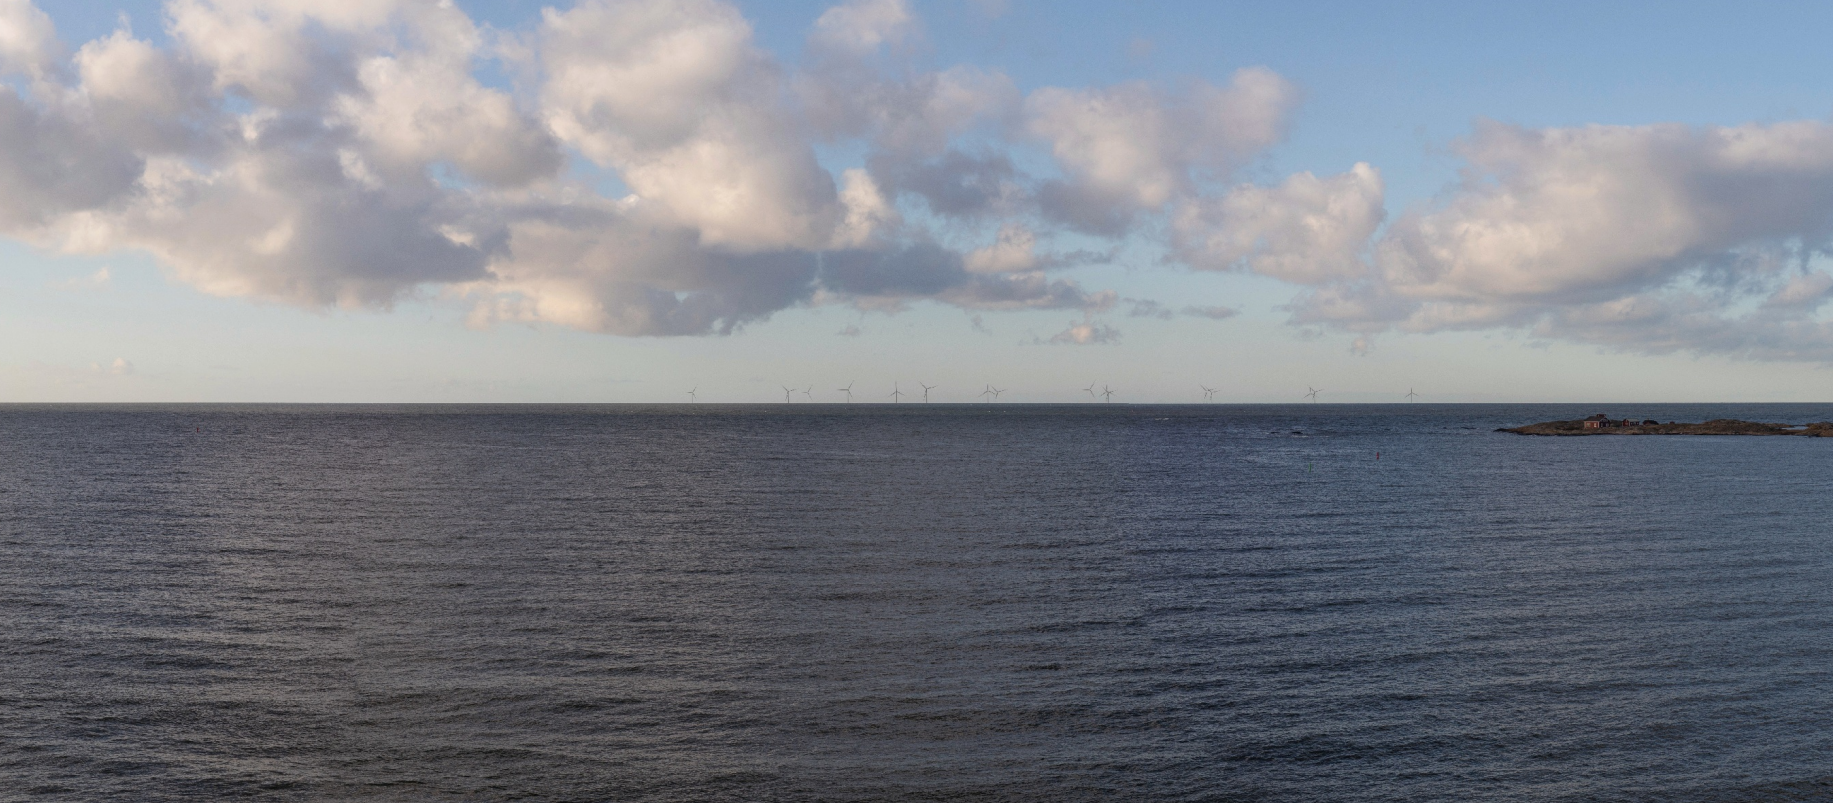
<box><xmin>539</xmin><ymin>0</ymin><xmax>845</xmax><ymax>251</ymax></box>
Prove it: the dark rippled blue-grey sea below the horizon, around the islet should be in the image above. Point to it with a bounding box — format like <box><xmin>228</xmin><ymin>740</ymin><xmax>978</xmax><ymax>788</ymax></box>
<box><xmin>0</xmin><ymin>403</ymin><xmax>1833</xmax><ymax>803</ymax></box>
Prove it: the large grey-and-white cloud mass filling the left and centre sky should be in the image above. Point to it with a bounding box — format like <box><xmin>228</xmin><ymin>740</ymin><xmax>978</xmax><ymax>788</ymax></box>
<box><xmin>0</xmin><ymin>0</ymin><xmax>1246</xmax><ymax>336</ymax></box>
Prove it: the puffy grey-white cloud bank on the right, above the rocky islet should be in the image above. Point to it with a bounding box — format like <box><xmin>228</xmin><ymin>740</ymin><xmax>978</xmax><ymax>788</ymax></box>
<box><xmin>1268</xmin><ymin>121</ymin><xmax>1833</xmax><ymax>361</ymax></box>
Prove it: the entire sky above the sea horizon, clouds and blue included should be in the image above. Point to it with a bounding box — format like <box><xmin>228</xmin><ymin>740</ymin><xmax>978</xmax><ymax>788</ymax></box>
<box><xmin>0</xmin><ymin>0</ymin><xmax>1833</xmax><ymax>403</ymax></box>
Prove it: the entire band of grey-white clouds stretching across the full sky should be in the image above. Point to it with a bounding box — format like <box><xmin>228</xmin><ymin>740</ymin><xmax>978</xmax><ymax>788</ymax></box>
<box><xmin>0</xmin><ymin>0</ymin><xmax>1833</xmax><ymax>361</ymax></box>
